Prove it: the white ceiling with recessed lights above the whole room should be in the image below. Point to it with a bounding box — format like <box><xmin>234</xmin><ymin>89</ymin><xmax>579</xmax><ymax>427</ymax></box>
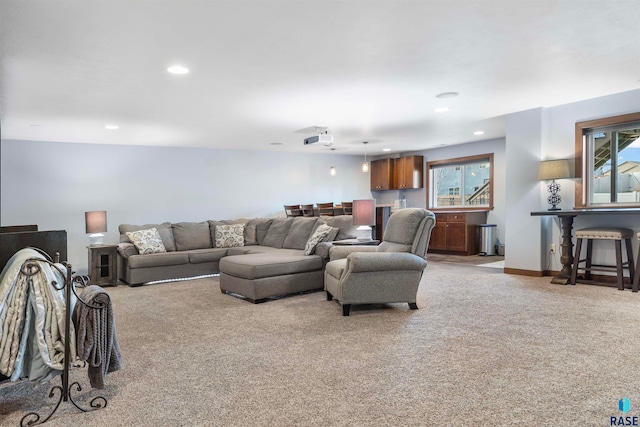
<box><xmin>0</xmin><ymin>0</ymin><xmax>640</xmax><ymax>155</ymax></box>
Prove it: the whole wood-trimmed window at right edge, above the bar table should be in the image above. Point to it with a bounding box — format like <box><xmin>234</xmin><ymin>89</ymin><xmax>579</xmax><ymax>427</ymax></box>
<box><xmin>576</xmin><ymin>113</ymin><xmax>640</xmax><ymax>207</ymax></box>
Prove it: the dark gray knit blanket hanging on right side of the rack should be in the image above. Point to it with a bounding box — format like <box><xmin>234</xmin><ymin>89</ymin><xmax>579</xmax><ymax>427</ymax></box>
<box><xmin>73</xmin><ymin>285</ymin><xmax>122</xmax><ymax>389</ymax></box>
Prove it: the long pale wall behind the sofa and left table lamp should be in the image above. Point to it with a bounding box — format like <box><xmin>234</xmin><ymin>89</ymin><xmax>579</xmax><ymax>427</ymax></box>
<box><xmin>0</xmin><ymin>140</ymin><xmax>371</xmax><ymax>274</ymax></box>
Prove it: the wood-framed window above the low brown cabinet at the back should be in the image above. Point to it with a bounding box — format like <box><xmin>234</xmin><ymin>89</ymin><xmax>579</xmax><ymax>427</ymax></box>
<box><xmin>427</xmin><ymin>154</ymin><xmax>493</xmax><ymax>209</ymax></box>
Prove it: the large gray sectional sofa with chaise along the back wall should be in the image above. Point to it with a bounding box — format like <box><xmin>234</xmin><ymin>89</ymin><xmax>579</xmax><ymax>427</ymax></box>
<box><xmin>118</xmin><ymin>215</ymin><xmax>356</xmax><ymax>302</ymax></box>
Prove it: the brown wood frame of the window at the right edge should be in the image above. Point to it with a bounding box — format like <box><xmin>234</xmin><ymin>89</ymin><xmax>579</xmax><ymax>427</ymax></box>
<box><xmin>575</xmin><ymin>112</ymin><xmax>640</xmax><ymax>209</ymax></box>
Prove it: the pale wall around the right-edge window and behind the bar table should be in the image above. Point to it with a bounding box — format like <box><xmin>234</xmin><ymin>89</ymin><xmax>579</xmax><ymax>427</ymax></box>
<box><xmin>505</xmin><ymin>90</ymin><xmax>640</xmax><ymax>271</ymax></box>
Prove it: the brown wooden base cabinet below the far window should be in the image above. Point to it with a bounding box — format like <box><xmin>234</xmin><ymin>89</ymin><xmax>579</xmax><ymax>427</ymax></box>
<box><xmin>429</xmin><ymin>211</ymin><xmax>487</xmax><ymax>255</ymax></box>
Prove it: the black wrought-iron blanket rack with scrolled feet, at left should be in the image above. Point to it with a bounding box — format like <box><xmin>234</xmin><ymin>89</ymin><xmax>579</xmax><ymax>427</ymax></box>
<box><xmin>20</xmin><ymin>252</ymin><xmax>109</xmax><ymax>426</ymax></box>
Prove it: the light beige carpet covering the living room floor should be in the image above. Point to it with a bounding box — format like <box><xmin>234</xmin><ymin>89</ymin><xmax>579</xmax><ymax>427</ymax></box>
<box><xmin>0</xmin><ymin>262</ymin><xmax>640</xmax><ymax>426</ymax></box>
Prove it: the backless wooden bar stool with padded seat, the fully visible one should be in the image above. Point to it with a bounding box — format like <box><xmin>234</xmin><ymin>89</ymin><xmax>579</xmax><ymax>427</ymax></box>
<box><xmin>569</xmin><ymin>227</ymin><xmax>635</xmax><ymax>291</ymax></box>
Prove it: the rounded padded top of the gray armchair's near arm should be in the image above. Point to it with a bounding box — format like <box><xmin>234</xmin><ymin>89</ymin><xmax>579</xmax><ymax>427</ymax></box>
<box><xmin>345</xmin><ymin>252</ymin><xmax>427</xmax><ymax>273</ymax></box>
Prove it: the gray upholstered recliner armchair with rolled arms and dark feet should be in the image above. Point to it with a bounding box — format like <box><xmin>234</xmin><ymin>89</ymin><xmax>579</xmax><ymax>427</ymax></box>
<box><xmin>324</xmin><ymin>208</ymin><xmax>436</xmax><ymax>316</ymax></box>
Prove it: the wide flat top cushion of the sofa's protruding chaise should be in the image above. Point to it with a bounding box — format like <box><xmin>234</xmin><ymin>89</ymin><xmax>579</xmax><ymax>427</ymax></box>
<box><xmin>220</xmin><ymin>253</ymin><xmax>322</xmax><ymax>279</ymax></box>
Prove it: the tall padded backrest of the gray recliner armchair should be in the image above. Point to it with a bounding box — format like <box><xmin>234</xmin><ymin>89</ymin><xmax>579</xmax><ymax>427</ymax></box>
<box><xmin>377</xmin><ymin>208</ymin><xmax>436</xmax><ymax>258</ymax></box>
